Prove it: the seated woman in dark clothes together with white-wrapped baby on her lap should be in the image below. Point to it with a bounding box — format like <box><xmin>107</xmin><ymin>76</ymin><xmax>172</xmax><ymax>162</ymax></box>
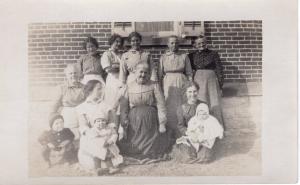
<box><xmin>171</xmin><ymin>82</ymin><xmax>223</xmax><ymax>163</ymax></box>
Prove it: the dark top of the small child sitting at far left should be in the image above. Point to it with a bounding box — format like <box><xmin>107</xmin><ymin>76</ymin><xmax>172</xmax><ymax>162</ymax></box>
<box><xmin>39</xmin><ymin>128</ymin><xmax>74</xmax><ymax>147</ymax></box>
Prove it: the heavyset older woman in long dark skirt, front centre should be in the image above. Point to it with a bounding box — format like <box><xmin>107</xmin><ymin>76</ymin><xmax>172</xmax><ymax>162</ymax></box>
<box><xmin>120</xmin><ymin>63</ymin><xmax>168</xmax><ymax>164</ymax></box>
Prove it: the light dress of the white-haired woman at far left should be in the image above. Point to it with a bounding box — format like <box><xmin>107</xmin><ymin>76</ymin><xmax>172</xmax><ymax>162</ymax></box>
<box><xmin>51</xmin><ymin>82</ymin><xmax>85</xmax><ymax>140</ymax></box>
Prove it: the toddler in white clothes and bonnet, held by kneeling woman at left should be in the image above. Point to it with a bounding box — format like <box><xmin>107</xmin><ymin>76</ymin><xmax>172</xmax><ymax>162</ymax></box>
<box><xmin>79</xmin><ymin>112</ymin><xmax>123</xmax><ymax>175</ymax></box>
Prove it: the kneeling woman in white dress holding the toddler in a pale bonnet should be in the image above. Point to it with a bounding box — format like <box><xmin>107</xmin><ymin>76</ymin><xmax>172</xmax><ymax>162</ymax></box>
<box><xmin>77</xmin><ymin>80</ymin><xmax>115</xmax><ymax>173</ymax></box>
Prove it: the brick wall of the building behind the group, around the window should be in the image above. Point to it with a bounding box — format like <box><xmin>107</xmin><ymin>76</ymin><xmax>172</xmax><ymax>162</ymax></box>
<box><xmin>28</xmin><ymin>21</ymin><xmax>262</xmax><ymax>86</ymax></box>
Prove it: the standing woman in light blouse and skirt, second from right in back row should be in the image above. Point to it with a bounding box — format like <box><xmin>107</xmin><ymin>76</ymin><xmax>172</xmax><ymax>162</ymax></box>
<box><xmin>158</xmin><ymin>36</ymin><xmax>193</xmax><ymax>139</ymax></box>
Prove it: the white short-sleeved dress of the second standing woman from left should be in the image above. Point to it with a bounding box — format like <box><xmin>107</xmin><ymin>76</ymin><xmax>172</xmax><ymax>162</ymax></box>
<box><xmin>101</xmin><ymin>49</ymin><xmax>122</xmax><ymax>114</ymax></box>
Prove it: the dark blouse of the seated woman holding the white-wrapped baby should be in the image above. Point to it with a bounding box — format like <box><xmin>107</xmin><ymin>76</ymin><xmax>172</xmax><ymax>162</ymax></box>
<box><xmin>177</xmin><ymin>100</ymin><xmax>205</xmax><ymax>135</ymax></box>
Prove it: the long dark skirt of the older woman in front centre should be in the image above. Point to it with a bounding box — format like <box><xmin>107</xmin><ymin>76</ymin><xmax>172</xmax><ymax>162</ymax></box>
<box><xmin>119</xmin><ymin>106</ymin><xmax>170</xmax><ymax>159</ymax></box>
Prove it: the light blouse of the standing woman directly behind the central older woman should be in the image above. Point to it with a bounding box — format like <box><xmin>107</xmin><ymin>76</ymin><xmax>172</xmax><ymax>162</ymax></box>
<box><xmin>120</xmin><ymin>49</ymin><xmax>157</xmax><ymax>84</ymax></box>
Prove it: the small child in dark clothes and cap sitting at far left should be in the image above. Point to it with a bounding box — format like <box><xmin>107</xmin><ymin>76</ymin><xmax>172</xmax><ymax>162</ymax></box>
<box><xmin>38</xmin><ymin>114</ymin><xmax>76</xmax><ymax>167</ymax></box>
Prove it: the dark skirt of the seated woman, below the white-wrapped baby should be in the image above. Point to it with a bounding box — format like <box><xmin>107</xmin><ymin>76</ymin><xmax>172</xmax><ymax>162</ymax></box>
<box><xmin>170</xmin><ymin>144</ymin><xmax>214</xmax><ymax>164</ymax></box>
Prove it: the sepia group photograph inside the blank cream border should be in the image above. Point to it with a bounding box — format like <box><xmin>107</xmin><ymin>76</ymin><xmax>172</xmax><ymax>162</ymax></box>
<box><xmin>27</xmin><ymin>19</ymin><xmax>264</xmax><ymax>178</ymax></box>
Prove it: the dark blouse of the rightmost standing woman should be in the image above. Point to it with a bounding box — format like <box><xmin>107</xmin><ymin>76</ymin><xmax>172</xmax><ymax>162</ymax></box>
<box><xmin>188</xmin><ymin>49</ymin><xmax>224</xmax><ymax>88</ymax></box>
